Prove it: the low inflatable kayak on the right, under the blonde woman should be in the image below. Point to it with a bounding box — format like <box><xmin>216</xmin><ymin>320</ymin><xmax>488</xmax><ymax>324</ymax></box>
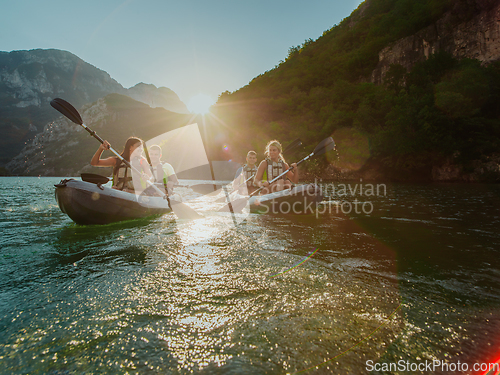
<box><xmin>221</xmin><ymin>184</ymin><xmax>323</xmax><ymax>214</ymax></box>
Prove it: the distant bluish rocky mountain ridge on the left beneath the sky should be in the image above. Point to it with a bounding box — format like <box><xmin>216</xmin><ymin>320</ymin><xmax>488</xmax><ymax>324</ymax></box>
<box><xmin>0</xmin><ymin>49</ymin><xmax>188</xmax><ymax>167</ymax></box>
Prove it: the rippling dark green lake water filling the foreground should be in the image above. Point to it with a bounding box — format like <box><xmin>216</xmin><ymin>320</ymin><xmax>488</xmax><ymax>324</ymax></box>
<box><xmin>0</xmin><ymin>178</ymin><xmax>500</xmax><ymax>374</ymax></box>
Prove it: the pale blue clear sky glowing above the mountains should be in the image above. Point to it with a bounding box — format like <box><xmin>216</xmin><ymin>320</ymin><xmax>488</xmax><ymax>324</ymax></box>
<box><xmin>0</xmin><ymin>0</ymin><xmax>362</xmax><ymax>110</ymax></box>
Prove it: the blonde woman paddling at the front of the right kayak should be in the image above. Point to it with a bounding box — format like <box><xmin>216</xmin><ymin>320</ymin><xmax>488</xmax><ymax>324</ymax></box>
<box><xmin>254</xmin><ymin>140</ymin><xmax>299</xmax><ymax>195</ymax></box>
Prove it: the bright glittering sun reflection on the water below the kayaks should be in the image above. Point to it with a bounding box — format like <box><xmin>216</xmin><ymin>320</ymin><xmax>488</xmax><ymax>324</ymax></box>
<box><xmin>123</xmin><ymin>216</ymin><xmax>248</xmax><ymax>371</ymax></box>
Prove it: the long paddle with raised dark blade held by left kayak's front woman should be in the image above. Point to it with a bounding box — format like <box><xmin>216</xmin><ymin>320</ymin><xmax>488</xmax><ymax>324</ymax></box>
<box><xmin>50</xmin><ymin>98</ymin><xmax>201</xmax><ymax>219</ymax></box>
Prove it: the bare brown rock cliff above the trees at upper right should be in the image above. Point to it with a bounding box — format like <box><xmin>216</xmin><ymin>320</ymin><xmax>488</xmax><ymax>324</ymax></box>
<box><xmin>371</xmin><ymin>0</ymin><xmax>500</xmax><ymax>83</ymax></box>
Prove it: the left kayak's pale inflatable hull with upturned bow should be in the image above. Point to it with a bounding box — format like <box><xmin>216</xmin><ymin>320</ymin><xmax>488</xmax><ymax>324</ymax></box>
<box><xmin>54</xmin><ymin>179</ymin><xmax>171</xmax><ymax>225</ymax></box>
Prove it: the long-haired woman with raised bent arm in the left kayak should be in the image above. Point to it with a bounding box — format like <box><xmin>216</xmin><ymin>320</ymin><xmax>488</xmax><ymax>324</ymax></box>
<box><xmin>90</xmin><ymin>137</ymin><xmax>150</xmax><ymax>193</ymax></box>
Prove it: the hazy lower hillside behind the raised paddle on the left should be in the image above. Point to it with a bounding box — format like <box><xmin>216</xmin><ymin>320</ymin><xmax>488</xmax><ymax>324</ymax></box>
<box><xmin>6</xmin><ymin>94</ymin><xmax>192</xmax><ymax>176</ymax></box>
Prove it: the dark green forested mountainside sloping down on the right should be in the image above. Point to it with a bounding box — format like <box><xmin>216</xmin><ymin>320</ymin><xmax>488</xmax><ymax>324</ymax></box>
<box><xmin>213</xmin><ymin>0</ymin><xmax>500</xmax><ymax>180</ymax></box>
